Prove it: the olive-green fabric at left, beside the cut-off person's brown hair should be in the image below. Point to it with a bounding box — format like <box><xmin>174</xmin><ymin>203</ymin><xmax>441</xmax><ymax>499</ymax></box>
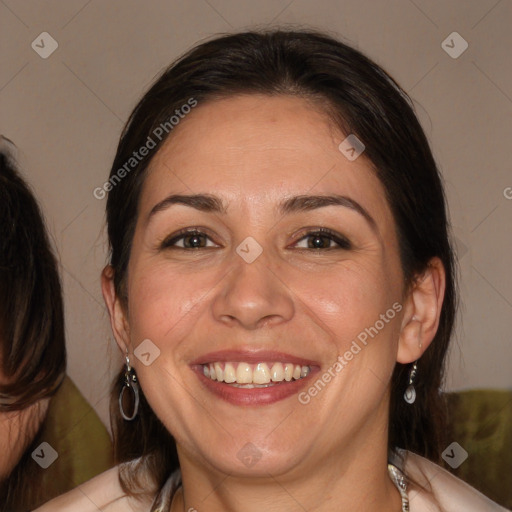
<box><xmin>35</xmin><ymin>376</ymin><xmax>114</xmax><ymax>501</ymax></box>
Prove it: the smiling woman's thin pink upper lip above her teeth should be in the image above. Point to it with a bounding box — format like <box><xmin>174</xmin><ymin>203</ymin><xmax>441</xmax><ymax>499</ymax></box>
<box><xmin>191</xmin><ymin>349</ymin><xmax>318</xmax><ymax>366</ymax></box>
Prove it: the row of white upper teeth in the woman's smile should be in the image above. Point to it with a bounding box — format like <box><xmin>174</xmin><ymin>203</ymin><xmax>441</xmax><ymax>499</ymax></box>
<box><xmin>203</xmin><ymin>362</ymin><xmax>311</xmax><ymax>388</ymax></box>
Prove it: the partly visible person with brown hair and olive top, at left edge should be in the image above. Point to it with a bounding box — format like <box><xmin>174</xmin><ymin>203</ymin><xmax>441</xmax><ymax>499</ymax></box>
<box><xmin>0</xmin><ymin>136</ymin><xmax>112</xmax><ymax>512</ymax></box>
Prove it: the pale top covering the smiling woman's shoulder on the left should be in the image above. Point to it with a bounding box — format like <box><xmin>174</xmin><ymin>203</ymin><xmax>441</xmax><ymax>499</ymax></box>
<box><xmin>34</xmin><ymin>466</ymin><xmax>152</xmax><ymax>512</ymax></box>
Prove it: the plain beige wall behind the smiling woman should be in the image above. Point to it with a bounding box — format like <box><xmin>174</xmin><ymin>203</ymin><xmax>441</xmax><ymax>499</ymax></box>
<box><xmin>0</xmin><ymin>0</ymin><xmax>512</xmax><ymax>423</ymax></box>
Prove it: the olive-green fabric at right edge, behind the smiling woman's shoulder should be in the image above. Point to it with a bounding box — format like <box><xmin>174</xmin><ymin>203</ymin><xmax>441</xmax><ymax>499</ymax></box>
<box><xmin>445</xmin><ymin>390</ymin><xmax>512</xmax><ymax>508</ymax></box>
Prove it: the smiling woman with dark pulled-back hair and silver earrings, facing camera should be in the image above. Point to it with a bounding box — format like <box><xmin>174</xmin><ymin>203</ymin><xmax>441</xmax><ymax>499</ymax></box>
<box><xmin>41</xmin><ymin>31</ymin><xmax>510</xmax><ymax>512</ymax></box>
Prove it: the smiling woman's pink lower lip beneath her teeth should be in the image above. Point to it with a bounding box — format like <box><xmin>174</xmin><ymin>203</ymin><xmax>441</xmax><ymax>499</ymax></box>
<box><xmin>194</xmin><ymin>366</ymin><xmax>316</xmax><ymax>405</ymax></box>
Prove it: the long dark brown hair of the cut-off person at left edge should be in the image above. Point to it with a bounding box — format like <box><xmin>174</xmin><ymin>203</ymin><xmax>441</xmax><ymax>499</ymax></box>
<box><xmin>0</xmin><ymin>142</ymin><xmax>66</xmax><ymax>511</ymax></box>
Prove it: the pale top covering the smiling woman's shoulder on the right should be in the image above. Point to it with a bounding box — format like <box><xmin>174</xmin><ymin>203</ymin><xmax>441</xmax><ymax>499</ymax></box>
<box><xmin>403</xmin><ymin>452</ymin><xmax>507</xmax><ymax>512</ymax></box>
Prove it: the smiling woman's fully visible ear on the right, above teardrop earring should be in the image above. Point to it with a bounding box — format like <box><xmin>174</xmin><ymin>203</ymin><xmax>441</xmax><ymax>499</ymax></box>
<box><xmin>396</xmin><ymin>257</ymin><xmax>446</xmax><ymax>364</ymax></box>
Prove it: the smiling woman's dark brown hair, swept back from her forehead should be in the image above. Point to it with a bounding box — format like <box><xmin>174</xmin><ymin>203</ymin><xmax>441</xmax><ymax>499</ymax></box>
<box><xmin>107</xmin><ymin>30</ymin><xmax>456</xmax><ymax>495</ymax></box>
